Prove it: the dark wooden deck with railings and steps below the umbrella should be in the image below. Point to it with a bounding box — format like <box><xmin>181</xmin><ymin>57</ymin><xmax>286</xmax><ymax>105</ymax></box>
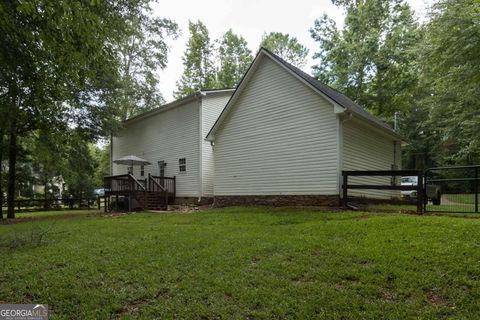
<box><xmin>104</xmin><ymin>174</ymin><xmax>176</xmax><ymax>211</ymax></box>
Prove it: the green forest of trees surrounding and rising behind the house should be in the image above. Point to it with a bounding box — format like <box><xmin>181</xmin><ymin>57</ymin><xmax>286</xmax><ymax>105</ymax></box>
<box><xmin>0</xmin><ymin>0</ymin><xmax>480</xmax><ymax>217</ymax></box>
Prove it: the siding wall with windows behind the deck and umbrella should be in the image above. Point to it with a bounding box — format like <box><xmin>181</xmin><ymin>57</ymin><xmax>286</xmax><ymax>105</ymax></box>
<box><xmin>113</xmin><ymin>100</ymin><xmax>201</xmax><ymax>197</ymax></box>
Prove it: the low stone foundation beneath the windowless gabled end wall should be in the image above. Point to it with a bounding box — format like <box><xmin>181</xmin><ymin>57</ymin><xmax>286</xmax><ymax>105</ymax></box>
<box><xmin>213</xmin><ymin>195</ymin><xmax>340</xmax><ymax>208</ymax></box>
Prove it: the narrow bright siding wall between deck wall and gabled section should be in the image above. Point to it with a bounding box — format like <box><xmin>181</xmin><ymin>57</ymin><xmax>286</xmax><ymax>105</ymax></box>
<box><xmin>201</xmin><ymin>91</ymin><xmax>232</xmax><ymax>197</ymax></box>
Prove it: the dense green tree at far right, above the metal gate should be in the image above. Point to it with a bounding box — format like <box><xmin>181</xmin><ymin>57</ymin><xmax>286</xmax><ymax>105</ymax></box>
<box><xmin>419</xmin><ymin>0</ymin><xmax>480</xmax><ymax>165</ymax></box>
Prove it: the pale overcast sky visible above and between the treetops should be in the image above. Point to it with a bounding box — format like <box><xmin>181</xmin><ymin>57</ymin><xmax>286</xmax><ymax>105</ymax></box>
<box><xmin>153</xmin><ymin>0</ymin><xmax>433</xmax><ymax>102</ymax></box>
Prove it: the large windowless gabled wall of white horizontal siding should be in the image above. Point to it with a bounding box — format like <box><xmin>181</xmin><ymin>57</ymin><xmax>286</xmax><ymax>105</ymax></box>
<box><xmin>214</xmin><ymin>58</ymin><xmax>338</xmax><ymax>195</ymax></box>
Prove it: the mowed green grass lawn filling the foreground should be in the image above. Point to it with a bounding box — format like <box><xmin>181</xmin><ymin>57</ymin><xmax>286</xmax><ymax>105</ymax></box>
<box><xmin>0</xmin><ymin>208</ymin><xmax>480</xmax><ymax>319</ymax></box>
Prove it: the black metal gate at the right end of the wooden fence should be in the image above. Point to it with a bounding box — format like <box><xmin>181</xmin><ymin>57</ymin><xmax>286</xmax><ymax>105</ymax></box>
<box><xmin>425</xmin><ymin>165</ymin><xmax>480</xmax><ymax>213</ymax></box>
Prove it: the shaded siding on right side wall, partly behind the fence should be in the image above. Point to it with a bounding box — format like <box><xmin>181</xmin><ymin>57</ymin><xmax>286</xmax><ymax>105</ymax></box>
<box><xmin>343</xmin><ymin>119</ymin><xmax>401</xmax><ymax>199</ymax></box>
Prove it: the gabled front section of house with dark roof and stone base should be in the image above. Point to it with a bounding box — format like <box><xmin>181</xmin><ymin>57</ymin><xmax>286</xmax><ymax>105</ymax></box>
<box><xmin>206</xmin><ymin>49</ymin><xmax>402</xmax><ymax>205</ymax></box>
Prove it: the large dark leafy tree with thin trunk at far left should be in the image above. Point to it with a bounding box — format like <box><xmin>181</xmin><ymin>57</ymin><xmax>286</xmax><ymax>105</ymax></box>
<box><xmin>0</xmin><ymin>0</ymin><xmax>148</xmax><ymax>218</ymax></box>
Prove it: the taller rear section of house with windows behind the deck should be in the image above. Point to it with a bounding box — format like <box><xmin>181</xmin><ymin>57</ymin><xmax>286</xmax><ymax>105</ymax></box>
<box><xmin>111</xmin><ymin>89</ymin><xmax>234</xmax><ymax>201</ymax></box>
